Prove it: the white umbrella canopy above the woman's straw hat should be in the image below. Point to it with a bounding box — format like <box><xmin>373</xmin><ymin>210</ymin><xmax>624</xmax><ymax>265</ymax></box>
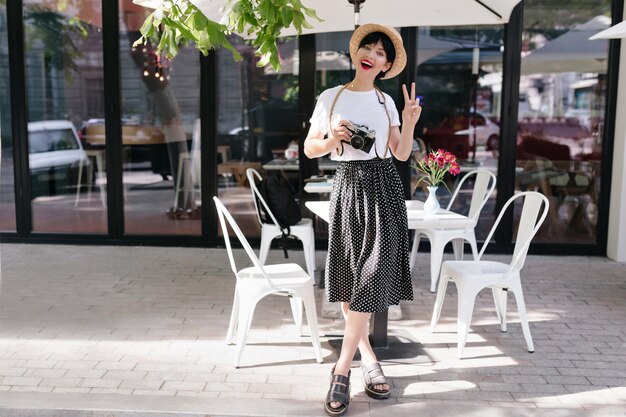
<box><xmin>133</xmin><ymin>0</ymin><xmax>520</xmax><ymax>36</ymax></box>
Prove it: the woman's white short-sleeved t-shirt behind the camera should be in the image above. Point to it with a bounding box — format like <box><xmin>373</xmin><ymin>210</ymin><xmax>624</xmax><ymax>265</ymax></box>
<box><xmin>310</xmin><ymin>86</ymin><xmax>400</xmax><ymax>161</ymax></box>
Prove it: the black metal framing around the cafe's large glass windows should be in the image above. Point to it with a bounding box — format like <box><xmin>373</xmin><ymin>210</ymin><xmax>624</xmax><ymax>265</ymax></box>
<box><xmin>0</xmin><ymin>0</ymin><xmax>624</xmax><ymax>255</ymax></box>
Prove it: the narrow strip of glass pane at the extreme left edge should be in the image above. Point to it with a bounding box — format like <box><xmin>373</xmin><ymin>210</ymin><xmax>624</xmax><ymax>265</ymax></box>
<box><xmin>0</xmin><ymin>4</ymin><xmax>15</xmax><ymax>232</ymax></box>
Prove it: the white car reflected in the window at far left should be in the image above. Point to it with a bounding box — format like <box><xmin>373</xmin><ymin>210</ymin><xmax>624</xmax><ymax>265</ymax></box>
<box><xmin>28</xmin><ymin>120</ymin><xmax>89</xmax><ymax>197</ymax></box>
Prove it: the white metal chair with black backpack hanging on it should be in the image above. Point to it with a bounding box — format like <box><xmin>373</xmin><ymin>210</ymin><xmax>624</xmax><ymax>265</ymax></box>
<box><xmin>246</xmin><ymin>168</ymin><xmax>315</xmax><ymax>278</ymax></box>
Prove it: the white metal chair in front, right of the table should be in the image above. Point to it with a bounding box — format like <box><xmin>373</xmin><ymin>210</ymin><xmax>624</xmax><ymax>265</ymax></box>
<box><xmin>430</xmin><ymin>191</ymin><xmax>550</xmax><ymax>358</ymax></box>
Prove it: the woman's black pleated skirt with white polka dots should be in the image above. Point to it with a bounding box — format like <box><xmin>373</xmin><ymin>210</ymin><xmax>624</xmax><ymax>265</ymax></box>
<box><xmin>326</xmin><ymin>158</ymin><xmax>413</xmax><ymax>313</ymax></box>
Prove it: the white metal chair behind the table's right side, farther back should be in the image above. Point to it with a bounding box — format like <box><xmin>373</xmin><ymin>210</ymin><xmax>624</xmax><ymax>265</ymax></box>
<box><xmin>410</xmin><ymin>169</ymin><xmax>496</xmax><ymax>292</ymax></box>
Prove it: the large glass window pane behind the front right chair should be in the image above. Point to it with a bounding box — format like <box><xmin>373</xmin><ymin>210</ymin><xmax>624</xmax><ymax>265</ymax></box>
<box><xmin>516</xmin><ymin>1</ymin><xmax>611</xmax><ymax>243</ymax></box>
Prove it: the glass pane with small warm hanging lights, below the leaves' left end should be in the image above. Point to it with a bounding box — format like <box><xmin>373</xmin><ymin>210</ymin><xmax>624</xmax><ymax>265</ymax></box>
<box><xmin>119</xmin><ymin>0</ymin><xmax>201</xmax><ymax>235</ymax></box>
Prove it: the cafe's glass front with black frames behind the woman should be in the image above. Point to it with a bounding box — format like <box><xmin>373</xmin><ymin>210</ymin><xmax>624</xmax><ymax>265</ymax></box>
<box><xmin>0</xmin><ymin>0</ymin><xmax>626</xmax><ymax>259</ymax></box>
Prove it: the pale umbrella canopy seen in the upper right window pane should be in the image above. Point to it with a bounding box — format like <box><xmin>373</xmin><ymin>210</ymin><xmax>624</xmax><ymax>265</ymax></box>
<box><xmin>522</xmin><ymin>16</ymin><xmax>611</xmax><ymax>75</ymax></box>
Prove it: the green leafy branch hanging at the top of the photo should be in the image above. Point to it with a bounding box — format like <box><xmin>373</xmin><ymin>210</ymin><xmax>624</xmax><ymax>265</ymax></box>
<box><xmin>133</xmin><ymin>0</ymin><xmax>322</xmax><ymax>71</ymax></box>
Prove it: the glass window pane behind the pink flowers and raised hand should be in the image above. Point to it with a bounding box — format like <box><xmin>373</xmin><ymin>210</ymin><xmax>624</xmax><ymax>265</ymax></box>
<box><xmin>412</xmin><ymin>26</ymin><xmax>504</xmax><ymax>240</ymax></box>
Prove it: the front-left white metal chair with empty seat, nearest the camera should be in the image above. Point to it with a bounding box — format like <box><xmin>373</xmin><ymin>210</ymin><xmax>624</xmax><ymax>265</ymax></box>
<box><xmin>213</xmin><ymin>197</ymin><xmax>323</xmax><ymax>368</ymax></box>
